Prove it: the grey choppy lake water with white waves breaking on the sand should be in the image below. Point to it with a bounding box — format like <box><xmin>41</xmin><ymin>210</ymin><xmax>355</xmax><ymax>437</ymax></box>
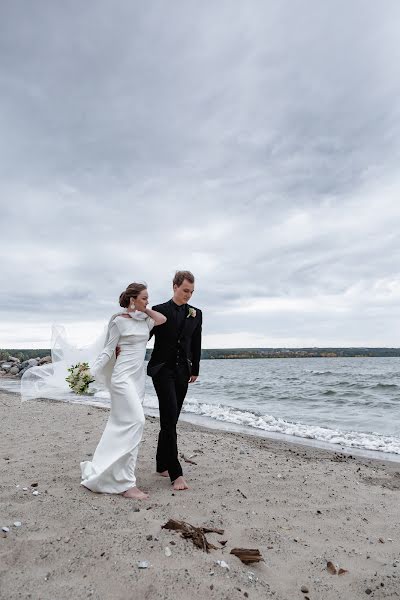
<box><xmin>0</xmin><ymin>356</ymin><xmax>400</xmax><ymax>462</ymax></box>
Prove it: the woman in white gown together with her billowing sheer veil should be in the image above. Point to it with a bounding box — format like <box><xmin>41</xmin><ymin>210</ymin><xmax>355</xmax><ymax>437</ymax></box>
<box><xmin>21</xmin><ymin>283</ymin><xmax>167</xmax><ymax>500</ymax></box>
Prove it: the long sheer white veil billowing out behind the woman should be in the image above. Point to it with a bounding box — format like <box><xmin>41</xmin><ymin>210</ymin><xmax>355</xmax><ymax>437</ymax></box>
<box><xmin>21</xmin><ymin>311</ymin><xmax>122</xmax><ymax>401</ymax></box>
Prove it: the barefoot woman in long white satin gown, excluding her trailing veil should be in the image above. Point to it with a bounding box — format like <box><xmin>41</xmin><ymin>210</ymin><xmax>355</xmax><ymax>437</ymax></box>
<box><xmin>81</xmin><ymin>283</ymin><xmax>167</xmax><ymax>500</ymax></box>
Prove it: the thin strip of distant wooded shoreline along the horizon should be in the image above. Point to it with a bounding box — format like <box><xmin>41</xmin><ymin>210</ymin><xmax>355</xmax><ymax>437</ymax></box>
<box><xmin>0</xmin><ymin>347</ymin><xmax>400</xmax><ymax>360</ymax></box>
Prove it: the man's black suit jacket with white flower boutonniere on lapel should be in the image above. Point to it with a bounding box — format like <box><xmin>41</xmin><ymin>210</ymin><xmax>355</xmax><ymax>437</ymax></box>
<box><xmin>147</xmin><ymin>300</ymin><xmax>203</xmax><ymax>377</ymax></box>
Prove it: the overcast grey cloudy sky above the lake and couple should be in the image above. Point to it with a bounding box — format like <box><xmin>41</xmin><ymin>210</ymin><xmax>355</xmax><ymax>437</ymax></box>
<box><xmin>0</xmin><ymin>0</ymin><xmax>400</xmax><ymax>348</ymax></box>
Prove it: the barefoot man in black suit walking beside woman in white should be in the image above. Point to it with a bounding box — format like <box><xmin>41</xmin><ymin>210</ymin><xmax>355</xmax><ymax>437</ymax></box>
<box><xmin>147</xmin><ymin>271</ymin><xmax>202</xmax><ymax>490</ymax></box>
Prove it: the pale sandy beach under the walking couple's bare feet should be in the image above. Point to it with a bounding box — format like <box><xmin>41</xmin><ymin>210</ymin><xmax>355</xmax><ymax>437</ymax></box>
<box><xmin>0</xmin><ymin>393</ymin><xmax>400</xmax><ymax>600</ymax></box>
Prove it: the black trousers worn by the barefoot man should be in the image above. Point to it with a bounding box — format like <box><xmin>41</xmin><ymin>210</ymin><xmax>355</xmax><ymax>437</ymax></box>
<box><xmin>153</xmin><ymin>365</ymin><xmax>189</xmax><ymax>482</ymax></box>
